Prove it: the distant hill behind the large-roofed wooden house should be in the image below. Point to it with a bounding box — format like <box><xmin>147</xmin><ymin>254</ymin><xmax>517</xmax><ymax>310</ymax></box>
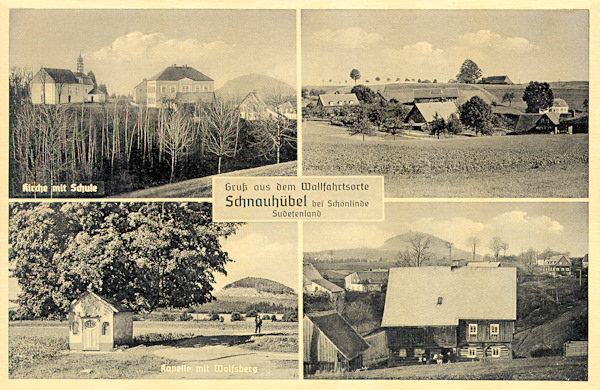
<box><xmin>305</xmin><ymin>232</ymin><xmax>481</xmax><ymax>265</ymax></box>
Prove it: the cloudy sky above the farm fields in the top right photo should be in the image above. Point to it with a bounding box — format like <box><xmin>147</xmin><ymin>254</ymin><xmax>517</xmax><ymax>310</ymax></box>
<box><xmin>301</xmin><ymin>10</ymin><xmax>589</xmax><ymax>85</ymax></box>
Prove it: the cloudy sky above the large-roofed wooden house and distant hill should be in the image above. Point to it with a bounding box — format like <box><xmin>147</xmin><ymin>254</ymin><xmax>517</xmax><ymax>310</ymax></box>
<box><xmin>303</xmin><ymin>202</ymin><xmax>588</xmax><ymax>256</ymax></box>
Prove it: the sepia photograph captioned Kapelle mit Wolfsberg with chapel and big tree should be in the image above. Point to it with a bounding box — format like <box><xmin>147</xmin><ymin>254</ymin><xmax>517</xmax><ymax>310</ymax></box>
<box><xmin>8</xmin><ymin>202</ymin><xmax>299</xmax><ymax>379</ymax></box>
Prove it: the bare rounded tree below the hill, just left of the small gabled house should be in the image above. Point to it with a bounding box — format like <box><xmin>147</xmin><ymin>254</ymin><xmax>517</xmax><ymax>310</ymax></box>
<box><xmin>201</xmin><ymin>99</ymin><xmax>240</xmax><ymax>174</ymax></box>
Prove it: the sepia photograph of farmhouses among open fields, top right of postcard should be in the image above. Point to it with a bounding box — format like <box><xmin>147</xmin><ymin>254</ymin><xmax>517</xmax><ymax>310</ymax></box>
<box><xmin>302</xmin><ymin>9</ymin><xmax>589</xmax><ymax>198</ymax></box>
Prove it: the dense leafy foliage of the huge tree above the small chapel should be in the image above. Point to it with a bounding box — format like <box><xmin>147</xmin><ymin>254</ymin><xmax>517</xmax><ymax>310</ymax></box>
<box><xmin>9</xmin><ymin>203</ymin><xmax>238</xmax><ymax>318</ymax></box>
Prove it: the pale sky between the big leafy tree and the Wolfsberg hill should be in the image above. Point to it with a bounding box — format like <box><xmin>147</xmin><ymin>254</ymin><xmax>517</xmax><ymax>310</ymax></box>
<box><xmin>214</xmin><ymin>222</ymin><xmax>298</xmax><ymax>291</ymax></box>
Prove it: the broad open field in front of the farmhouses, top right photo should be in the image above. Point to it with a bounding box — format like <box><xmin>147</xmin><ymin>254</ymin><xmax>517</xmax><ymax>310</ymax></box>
<box><xmin>303</xmin><ymin>122</ymin><xmax>589</xmax><ymax>198</ymax></box>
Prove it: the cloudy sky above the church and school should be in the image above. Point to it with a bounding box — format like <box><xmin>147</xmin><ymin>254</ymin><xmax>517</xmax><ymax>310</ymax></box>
<box><xmin>9</xmin><ymin>9</ymin><xmax>296</xmax><ymax>94</ymax></box>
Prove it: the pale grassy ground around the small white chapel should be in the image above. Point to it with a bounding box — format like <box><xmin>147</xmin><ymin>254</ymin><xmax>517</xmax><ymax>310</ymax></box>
<box><xmin>8</xmin><ymin>319</ymin><xmax>298</xmax><ymax>379</ymax></box>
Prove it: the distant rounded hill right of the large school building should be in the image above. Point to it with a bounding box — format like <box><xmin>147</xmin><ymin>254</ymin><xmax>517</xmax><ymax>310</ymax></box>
<box><xmin>215</xmin><ymin>74</ymin><xmax>296</xmax><ymax>100</ymax></box>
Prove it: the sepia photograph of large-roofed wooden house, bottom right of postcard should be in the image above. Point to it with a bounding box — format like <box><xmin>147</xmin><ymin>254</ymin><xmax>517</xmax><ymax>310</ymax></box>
<box><xmin>303</xmin><ymin>202</ymin><xmax>589</xmax><ymax>381</ymax></box>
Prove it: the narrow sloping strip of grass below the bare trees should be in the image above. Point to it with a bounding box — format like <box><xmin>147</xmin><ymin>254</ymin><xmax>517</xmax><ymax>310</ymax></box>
<box><xmin>113</xmin><ymin>161</ymin><xmax>297</xmax><ymax>198</ymax></box>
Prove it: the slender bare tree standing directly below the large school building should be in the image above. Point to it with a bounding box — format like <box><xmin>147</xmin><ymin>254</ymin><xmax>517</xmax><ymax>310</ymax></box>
<box><xmin>161</xmin><ymin>110</ymin><xmax>193</xmax><ymax>182</ymax></box>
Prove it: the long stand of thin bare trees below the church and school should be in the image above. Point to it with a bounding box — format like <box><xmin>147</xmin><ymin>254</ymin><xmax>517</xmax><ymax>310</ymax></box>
<box><xmin>10</xmin><ymin>70</ymin><xmax>296</xmax><ymax>194</ymax></box>
